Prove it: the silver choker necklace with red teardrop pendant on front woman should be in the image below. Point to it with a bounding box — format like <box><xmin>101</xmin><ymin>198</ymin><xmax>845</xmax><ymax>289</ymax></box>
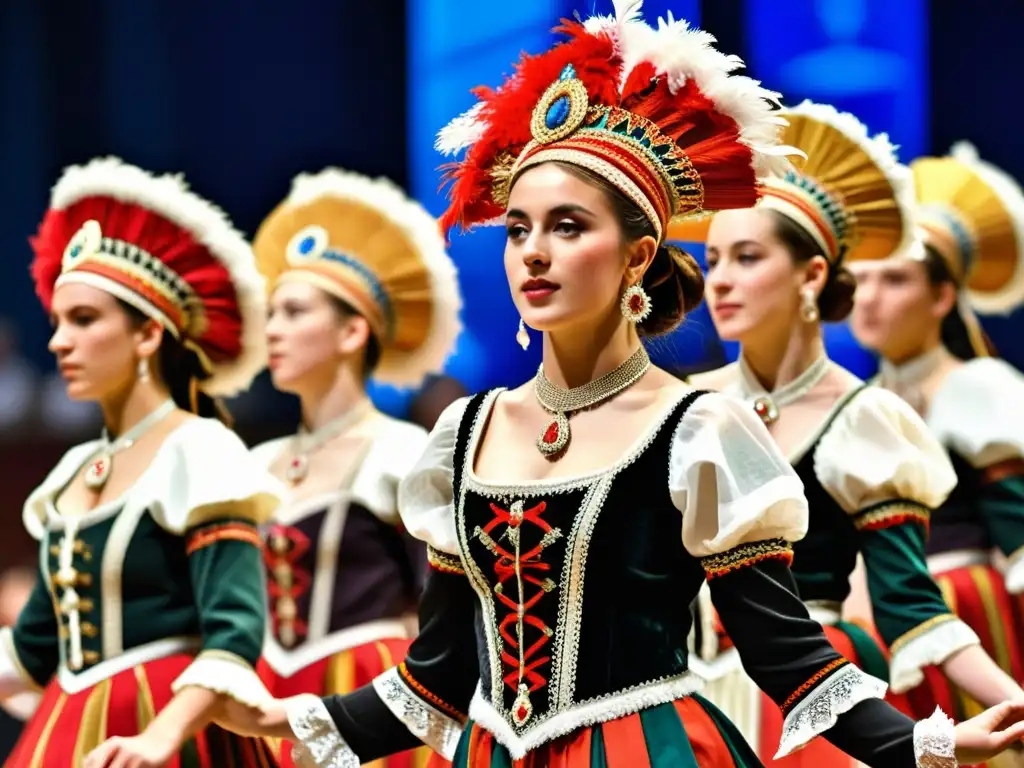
<box><xmin>534</xmin><ymin>346</ymin><xmax>650</xmax><ymax>459</ymax></box>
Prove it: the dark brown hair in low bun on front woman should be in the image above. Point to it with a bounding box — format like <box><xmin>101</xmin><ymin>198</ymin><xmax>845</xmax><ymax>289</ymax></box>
<box><xmin>552</xmin><ymin>161</ymin><xmax>703</xmax><ymax>337</ymax></box>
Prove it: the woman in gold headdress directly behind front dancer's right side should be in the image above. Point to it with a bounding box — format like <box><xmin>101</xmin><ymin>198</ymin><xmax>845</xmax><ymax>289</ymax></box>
<box><xmin>676</xmin><ymin>102</ymin><xmax>1024</xmax><ymax>765</ymax></box>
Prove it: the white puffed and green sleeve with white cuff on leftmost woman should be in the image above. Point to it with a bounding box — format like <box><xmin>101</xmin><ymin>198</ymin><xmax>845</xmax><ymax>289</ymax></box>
<box><xmin>146</xmin><ymin>419</ymin><xmax>285</xmax><ymax>705</ymax></box>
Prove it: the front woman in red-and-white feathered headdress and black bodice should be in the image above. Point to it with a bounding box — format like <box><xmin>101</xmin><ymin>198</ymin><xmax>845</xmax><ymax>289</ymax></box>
<box><xmin>205</xmin><ymin>3</ymin><xmax>1019</xmax><ymax>768</ymax></box>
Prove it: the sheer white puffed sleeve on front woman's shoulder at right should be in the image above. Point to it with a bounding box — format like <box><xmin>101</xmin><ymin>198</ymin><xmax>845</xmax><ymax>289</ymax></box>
<box><xmin>669</xmin><ymin>393</ymin><xmax>808</xmax><ymax>557</ymax></box>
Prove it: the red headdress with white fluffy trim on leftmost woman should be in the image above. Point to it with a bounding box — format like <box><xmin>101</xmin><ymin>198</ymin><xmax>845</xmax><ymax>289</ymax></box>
<box><xmin>32</xmin><ymin>158</ymin><xmax>266</xmax><ymax>395</ymax></box>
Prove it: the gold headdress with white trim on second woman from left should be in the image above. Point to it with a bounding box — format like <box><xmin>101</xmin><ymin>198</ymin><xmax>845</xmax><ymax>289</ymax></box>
<box><xmin>253</xmin><ymin>168</ymin><xmax>462</xmax><ymax>386</ymax></box>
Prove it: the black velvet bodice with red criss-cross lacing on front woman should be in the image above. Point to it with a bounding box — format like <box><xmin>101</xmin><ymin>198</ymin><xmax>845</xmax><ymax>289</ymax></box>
<box><xmin>456</xmin><ymin>393</ymin><xmax>705</xmax><ymax>727</ymax></box>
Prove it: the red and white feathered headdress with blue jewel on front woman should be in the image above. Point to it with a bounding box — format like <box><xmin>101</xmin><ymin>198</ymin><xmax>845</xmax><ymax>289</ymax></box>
<box><xmin>436</xmin><ymin>0</ymin><xmax>793</xmax><ymax>238</ymax></box>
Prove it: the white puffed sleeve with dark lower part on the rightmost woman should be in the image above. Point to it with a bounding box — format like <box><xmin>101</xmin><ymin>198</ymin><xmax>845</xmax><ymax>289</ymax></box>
<box><xmin>928</xmin><ymin>357</ymin><xmax>1024</xmax><ymax>594</ymax></box>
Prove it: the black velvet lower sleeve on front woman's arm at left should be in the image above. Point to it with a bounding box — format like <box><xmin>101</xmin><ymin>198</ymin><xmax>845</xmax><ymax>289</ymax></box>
<box><xmin>315</xmin><ymin>565</ymin><xmax>480</xmax><ymax>763</ymax></box>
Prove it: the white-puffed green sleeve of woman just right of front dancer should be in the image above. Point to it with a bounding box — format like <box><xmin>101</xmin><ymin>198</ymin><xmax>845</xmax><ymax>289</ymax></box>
<box><xmin>814</xmin><ymin>387</ymin><xmax>978</xmax><ymax>693</ymax></box>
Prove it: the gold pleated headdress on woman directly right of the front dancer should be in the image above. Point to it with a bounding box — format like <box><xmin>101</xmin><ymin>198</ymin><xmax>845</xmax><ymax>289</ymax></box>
<box><xmin>671</xmin><ymin>101</ymin><xmax>913</xmax><ymax>264</ymax></box>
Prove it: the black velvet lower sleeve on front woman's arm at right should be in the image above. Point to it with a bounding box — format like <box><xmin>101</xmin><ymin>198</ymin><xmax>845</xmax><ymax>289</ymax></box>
<box><xmin>702</xmin><ymin>540</ymin><xmax>915</xmax><ymax>768</ymax></box>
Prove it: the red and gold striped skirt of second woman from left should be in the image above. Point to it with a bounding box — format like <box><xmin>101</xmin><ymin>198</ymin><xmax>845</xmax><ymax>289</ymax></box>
<box><xmin>257</xmin><ymin>639</ymin><xmax>450</xmax><ymax>768</ymax></box>
